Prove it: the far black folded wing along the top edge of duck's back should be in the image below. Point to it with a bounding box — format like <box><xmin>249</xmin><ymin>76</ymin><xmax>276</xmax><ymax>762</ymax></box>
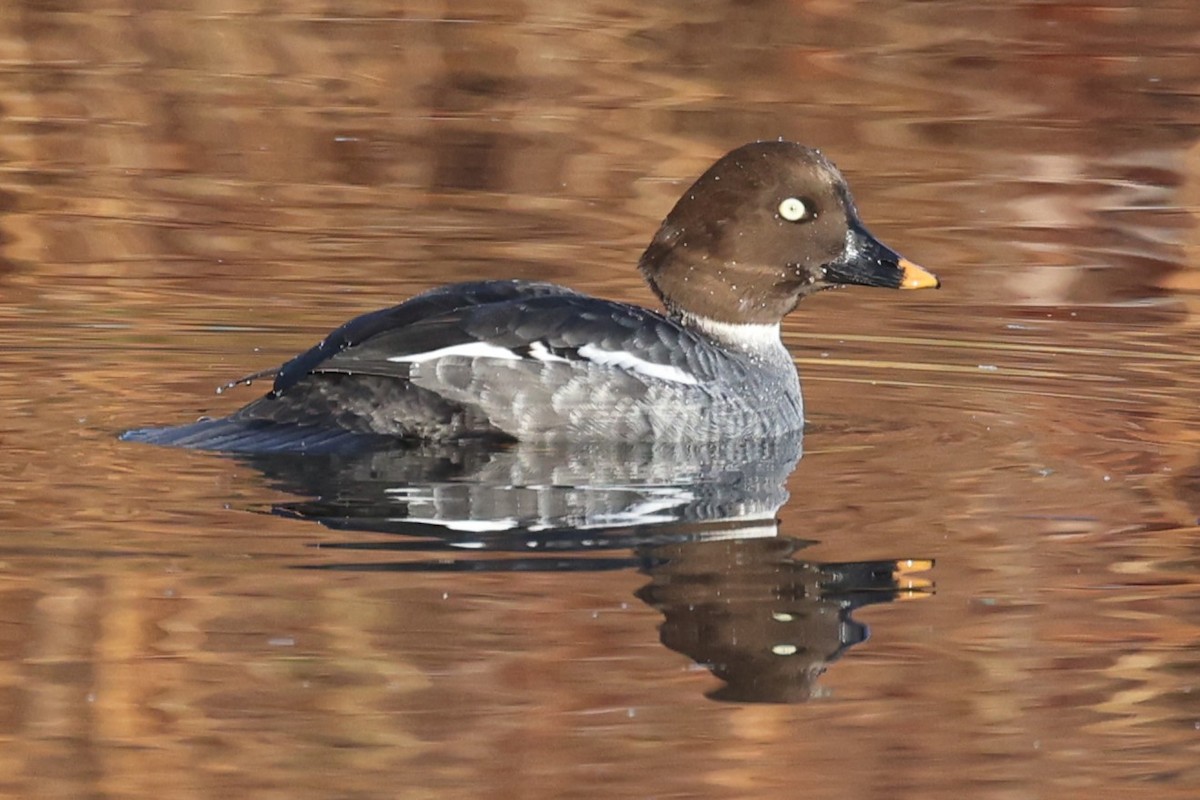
<box><xmin>266</xmin><ymin>281</ymin><xmax>578</xmax><ymax>395</ymax></box>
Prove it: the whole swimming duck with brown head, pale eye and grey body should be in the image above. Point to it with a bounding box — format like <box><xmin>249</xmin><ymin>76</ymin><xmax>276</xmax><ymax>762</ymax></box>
<box><xmin>124</xmin><ymin>142</ymin><xmax>938</xmax><ymax>450</ymax></box>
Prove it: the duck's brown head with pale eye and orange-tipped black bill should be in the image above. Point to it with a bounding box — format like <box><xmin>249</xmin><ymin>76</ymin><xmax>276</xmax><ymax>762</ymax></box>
<box><xmin>638</xmin><ymin>142</ymin><xmax>940</xmax><ymax>324</ymax></box>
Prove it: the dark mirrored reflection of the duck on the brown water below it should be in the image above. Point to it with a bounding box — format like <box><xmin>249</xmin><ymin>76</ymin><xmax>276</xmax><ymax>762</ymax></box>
<box><xmin>240</xmin><ymin>437</ymin><xmax>932</xmax><ymax>703</ymax></box>
